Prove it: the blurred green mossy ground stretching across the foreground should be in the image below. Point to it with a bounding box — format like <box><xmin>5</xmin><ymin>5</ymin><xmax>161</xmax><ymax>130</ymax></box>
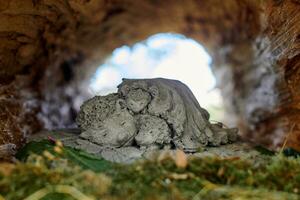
<box><xmin>0</xmin><ymin>142</ymin><xmax>300</xmax><ymax>200</ymax></box>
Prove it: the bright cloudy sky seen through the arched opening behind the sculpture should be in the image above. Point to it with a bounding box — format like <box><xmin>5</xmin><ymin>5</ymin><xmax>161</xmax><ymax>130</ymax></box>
<box><xmin>90</xmin><ymin>34</ymin><xmax>223</xmax><ymax>120</ymax></box>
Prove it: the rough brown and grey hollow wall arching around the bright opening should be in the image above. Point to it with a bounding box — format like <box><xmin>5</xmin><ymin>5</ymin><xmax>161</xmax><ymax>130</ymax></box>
<box><xmin>0</xmin><ymin>0</ymin><xmax>300</xmax><ymax>149</ymax></box>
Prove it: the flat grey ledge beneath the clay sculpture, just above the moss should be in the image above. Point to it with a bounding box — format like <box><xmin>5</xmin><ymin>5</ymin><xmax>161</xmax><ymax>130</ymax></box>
<box><xmin>28</xmin><ymin>129</ymin><xmax>265</xmax><ymax>163</ymax></box>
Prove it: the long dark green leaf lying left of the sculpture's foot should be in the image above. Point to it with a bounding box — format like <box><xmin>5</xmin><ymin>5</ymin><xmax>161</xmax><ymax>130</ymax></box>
<box><xmin>16</xmin><ymin>140</ymin><xmax>112</xmax><ymax>172</ymax></box>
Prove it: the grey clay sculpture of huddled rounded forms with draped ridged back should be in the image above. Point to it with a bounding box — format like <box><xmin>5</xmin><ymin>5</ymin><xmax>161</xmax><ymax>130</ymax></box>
<box><xmin>77</xmin><ymin>78</ymin><xmax>237</xmax><ymax>161</ymax></box>
